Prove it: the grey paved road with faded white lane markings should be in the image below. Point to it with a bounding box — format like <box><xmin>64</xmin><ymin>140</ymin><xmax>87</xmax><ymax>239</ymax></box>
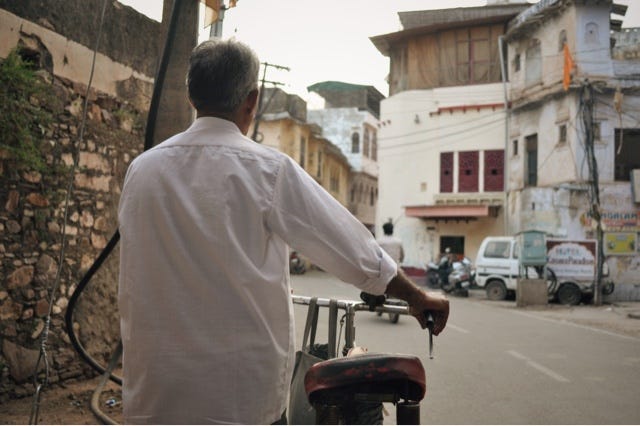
<box><xmin>292</xmin><ymin>271</ymin><xmax>640</xmax><ymax>424</ymax></box>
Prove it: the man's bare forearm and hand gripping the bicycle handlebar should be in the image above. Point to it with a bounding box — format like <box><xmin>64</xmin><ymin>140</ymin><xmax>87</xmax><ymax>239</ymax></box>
<box><xmin>386</xmin><ymin>268</ymin><xmax>449</xmax><ymax>336</ymax></box>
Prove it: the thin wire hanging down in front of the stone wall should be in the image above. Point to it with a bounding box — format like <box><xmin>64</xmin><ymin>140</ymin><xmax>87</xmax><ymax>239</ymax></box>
<box><xmin>29</xmin><ymin>0</ymin><xmax>108</xmax><ymax>424</ymax></box>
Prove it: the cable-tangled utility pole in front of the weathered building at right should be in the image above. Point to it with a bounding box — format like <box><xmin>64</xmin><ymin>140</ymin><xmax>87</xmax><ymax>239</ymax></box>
<box><xmin>580</xmin><ymin>81</ymin><xmax>604</xmax><ymax>306</ymax></box>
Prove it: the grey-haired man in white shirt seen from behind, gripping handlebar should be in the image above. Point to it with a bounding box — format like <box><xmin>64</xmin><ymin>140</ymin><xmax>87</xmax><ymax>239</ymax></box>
<box><xmin>118</xmin><ymin>40</ymin><xmax>449</xmax><ymax>424</ymax></box>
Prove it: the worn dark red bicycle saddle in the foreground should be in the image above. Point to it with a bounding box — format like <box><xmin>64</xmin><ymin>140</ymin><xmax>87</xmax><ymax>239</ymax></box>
<box><xmin>304</xmin><ymin>354</ymin><xmax>426</xmax><ymax>403</ymax></box>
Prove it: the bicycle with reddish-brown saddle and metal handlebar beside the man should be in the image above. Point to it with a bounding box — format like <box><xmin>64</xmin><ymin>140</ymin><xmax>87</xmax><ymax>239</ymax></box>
<box><xmin>292</xmin><ymin>293</ymin><xmax>433</xmax><ymax>424</ymax></box>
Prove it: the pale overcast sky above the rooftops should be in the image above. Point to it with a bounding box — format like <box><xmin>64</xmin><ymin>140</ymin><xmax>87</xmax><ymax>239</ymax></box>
<box><xmin>119</xmin><ymin>0</ymin><xmax>640</xmax><ymax>107</ymax></box>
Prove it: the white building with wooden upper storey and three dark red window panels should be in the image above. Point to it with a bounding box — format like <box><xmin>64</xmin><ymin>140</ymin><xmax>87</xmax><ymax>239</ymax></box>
<box><xmin>371</xmin><ymin>4</ymin><xmax>528</xmax><ymax>267</ymax></box>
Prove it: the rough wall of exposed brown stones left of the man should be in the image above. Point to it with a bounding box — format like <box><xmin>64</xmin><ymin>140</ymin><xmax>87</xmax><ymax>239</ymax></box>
<box><xmin>0</xmin><ymin>63</ymin><xmax>145</xmax><ymax>403</ymax></box>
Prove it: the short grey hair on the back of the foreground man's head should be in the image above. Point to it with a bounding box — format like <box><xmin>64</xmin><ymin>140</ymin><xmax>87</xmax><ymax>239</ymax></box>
<box><xmin>187</xmin><ymin>39</ymin><xmax>260</xmax><ymax>113</ymax></box>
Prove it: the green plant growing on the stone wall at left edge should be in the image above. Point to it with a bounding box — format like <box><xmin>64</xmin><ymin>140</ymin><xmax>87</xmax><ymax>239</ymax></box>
<box><xmin>0</xmin><ymin>49</ymin><xmax>53</xmax><ymax>172</ymax></box>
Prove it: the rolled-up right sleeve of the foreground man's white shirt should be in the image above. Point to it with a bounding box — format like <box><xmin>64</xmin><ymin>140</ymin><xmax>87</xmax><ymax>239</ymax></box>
<box><xmin>267</xmin><ymin>157</ymin><xmax>398</xmax><ymax>294</ymax></box>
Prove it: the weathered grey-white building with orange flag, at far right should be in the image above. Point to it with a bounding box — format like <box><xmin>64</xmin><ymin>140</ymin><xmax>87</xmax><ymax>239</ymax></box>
<box><xmin>504</xmin><ymin>0</ymin><xmax>640</xmax><ymax>300</ymax></box>
